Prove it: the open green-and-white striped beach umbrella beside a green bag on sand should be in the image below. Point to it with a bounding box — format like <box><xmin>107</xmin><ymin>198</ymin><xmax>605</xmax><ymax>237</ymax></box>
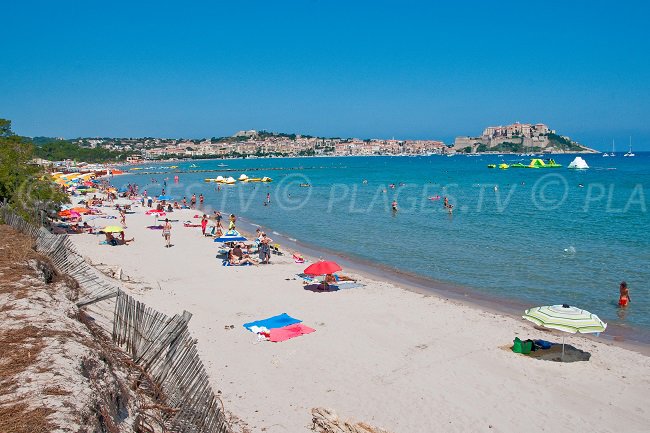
<box><xmin>521</xmin><ymin>304</ymin><xmax>607</xmax><ymax>357</ymax></box>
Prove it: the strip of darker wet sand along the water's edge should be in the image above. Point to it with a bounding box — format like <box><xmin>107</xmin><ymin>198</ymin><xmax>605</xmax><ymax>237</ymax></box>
<box><xmin>237</xmin><ymin>212</ymin><xmax>650</xmax><ymax>356</ymax></box>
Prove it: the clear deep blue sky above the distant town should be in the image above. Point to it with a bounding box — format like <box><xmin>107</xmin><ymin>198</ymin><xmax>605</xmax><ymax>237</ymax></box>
<box><xmin>0</xmin><ymin>0</ymin><xmax>650</xmax><ymax>150</ymax></box>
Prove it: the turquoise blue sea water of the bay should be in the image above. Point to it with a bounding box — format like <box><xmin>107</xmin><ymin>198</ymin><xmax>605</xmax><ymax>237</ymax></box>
<box><xmin>115</xmin><ymin>153</ymin><xmax>650</xmax><ymax>338</ymax></box>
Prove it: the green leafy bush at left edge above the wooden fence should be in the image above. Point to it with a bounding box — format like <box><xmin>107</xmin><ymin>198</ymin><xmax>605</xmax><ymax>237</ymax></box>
<box><xmin>0</xmin><ymin>119</ymin><xmax>68</xmax><ymax>219</ymax></box>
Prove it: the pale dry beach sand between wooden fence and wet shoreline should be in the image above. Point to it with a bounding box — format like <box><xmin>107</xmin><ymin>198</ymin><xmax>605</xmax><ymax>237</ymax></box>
<box><xmin>72</xmin><ymin>201</ymin><xmax>650</xmax><ymax>433</ymax></box>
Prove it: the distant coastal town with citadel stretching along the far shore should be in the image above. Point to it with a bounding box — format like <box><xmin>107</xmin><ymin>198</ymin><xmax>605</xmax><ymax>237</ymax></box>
<box><xmin>49</xmin><ymin>122</ymin><xmax>595</xmax><ymax>162</ymax></box>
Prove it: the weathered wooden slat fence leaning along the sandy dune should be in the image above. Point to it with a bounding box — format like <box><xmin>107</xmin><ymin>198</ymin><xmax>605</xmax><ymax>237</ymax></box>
<box><xmin>0</xmin><ymin>204</ymin><xmax>231</xmax><ymax>433</ymax></box>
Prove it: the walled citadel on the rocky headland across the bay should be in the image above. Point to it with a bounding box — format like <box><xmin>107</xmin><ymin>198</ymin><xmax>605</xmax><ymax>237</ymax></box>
<box><xmin>453</xmin><ymin>122</ymin><xmax>597</xmax><ymax>153</ymax></box>
